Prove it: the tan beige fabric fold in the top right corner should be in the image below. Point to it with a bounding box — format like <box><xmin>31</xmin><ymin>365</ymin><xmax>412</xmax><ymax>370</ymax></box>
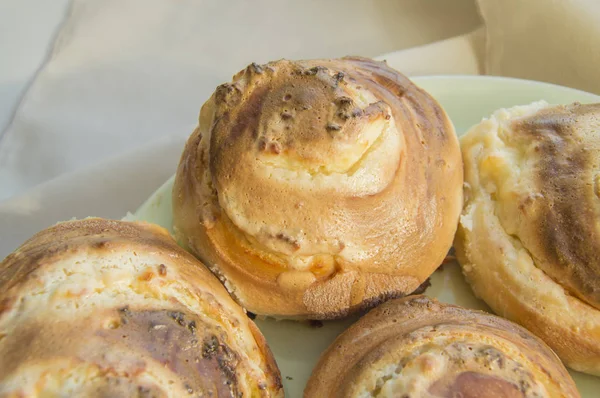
<box><xmin>478</xmin><ymin>0</ymin><xmax>600</xmax><ymax>94</ymax></box>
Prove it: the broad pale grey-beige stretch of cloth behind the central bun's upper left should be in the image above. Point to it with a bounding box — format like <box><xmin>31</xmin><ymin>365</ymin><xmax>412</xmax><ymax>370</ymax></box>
<box><xmin>0</xmin><ymin>0</ymin><xmax>480</xmax><ymax>199</ymax></box>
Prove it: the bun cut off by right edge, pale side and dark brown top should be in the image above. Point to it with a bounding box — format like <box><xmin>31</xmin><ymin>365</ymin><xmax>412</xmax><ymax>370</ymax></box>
<box><xmin>456</xmin><ymin>102</ymin><xmax>600</xmax><ymax>375</ymax></box>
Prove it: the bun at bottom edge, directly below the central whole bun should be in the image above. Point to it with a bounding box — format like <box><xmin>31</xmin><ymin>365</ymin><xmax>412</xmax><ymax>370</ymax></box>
<box><xmin>304</xmin><ymin>296</ymin><xmax>579</xmax><ymax>398</ymax></box>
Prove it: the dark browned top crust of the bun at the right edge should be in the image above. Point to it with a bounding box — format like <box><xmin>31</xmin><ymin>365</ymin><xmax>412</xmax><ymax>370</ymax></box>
<box><xmin>504</xmin><ymin>104</ymin><xmax>600</xmax><ymax>309</ymax></box>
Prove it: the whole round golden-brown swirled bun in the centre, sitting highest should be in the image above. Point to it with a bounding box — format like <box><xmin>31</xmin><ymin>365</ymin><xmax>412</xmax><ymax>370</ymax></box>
<box><xmin>173</xmin><ymin>58</ymin><xmax>462</xmax><ymax>319</ymax></box>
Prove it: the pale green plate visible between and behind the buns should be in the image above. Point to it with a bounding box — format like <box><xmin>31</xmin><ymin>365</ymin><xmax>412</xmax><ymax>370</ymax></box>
<box><xmin>132</xmin><ymin>76</ymin><xmax>600</xmax><ymax>398</ymax></box>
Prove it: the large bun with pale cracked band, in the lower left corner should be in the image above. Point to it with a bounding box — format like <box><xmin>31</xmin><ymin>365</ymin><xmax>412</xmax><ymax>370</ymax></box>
<box><xmin>0</xmin><ymin>219</ymin><xmax>283</xmax><ymax>397</ymax></box>
